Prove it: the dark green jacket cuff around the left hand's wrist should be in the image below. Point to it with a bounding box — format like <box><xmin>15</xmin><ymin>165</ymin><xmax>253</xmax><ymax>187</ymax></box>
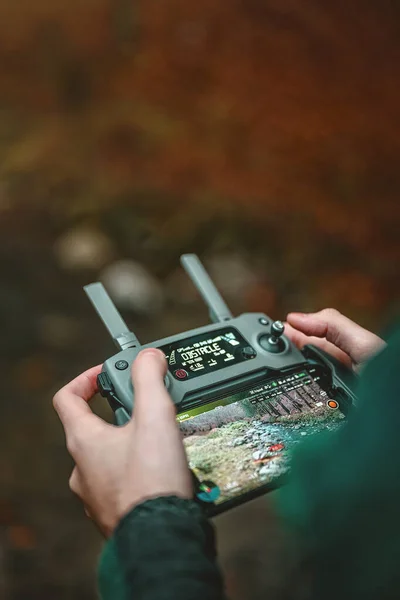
<box><xmin>99</xmin><ymin>497</ymin><xmax>224</xmax><ymax>600</ymax></box>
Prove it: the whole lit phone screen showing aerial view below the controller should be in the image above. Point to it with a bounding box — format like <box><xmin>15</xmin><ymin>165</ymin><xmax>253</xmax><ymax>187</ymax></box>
<box><xmin>178</xmin><ymin>367</ymin><xmax>344</xmax><ymax>505</ymax></box>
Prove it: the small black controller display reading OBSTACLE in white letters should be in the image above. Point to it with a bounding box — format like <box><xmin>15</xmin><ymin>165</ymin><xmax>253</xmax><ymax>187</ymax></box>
<box><xmin>160</xmin><ymin>327</ymin><xmax>256</xmax><ymax>380</ymax></box>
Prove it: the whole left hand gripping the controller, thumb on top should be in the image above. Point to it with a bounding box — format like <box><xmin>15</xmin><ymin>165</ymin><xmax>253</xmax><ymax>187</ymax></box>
<box><xmin>53</xmin><ymin>349</ymin><xmax>192</xmax><ymax>536</ymax></box>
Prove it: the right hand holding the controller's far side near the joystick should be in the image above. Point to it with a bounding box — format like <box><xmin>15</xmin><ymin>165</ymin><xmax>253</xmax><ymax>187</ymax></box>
<box><xmin>285</xmin><ymin>308</ymin><xmax>386</xmax><ymax>370</ymax></box>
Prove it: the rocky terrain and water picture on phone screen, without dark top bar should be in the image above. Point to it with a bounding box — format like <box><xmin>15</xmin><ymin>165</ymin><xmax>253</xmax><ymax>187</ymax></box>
<box><xmin>181</xmin><ymin>386</ymin><xmax>343</xmax><ymax>501</ymax></box>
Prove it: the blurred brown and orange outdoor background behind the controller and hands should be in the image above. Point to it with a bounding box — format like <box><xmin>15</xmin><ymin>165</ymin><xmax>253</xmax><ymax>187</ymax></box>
<box><xmin>0</xmin><ymin>0</ymin><xmax>400</xmax><ymax>600</ymax></box>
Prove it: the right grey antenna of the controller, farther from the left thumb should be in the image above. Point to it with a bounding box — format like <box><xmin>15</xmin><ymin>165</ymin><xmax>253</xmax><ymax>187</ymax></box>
<box><xmin>181</xmin><ymin>254</ymin><xmax>233</xmax><ymax>323</ymax></box>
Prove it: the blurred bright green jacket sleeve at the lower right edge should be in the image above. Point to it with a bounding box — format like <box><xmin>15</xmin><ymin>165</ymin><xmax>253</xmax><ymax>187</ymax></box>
<box><xmin>278</xmin><ymin>331</ymin><xmax>400</xmax><ymax>600</ymax></box>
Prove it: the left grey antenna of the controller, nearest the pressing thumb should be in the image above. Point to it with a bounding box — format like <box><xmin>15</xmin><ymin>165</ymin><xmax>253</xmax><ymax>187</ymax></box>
<box><xmin>84</xmin><ymin>283</ymin><xmax>140</xmax><ymax>350</ymax></box>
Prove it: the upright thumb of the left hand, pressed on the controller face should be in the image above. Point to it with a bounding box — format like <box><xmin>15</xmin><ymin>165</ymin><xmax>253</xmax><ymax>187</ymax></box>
<box><xmin>132</xmin><ymin>348</ymin><xmax>176</xmax><ymax>424</ymax></box>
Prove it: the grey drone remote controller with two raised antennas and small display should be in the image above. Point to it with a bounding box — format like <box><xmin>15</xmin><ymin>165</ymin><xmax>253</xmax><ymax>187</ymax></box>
<box><xmin>85</xmin><ymin>254</ymin><xmax>355</xmax><ymax>512</ymax></box>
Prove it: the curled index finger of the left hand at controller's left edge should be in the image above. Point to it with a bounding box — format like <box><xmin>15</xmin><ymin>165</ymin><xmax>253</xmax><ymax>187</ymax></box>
<box><xmin>53</xmin><ymin>365</ymin><xmax>102</xmax><ymax>429</ymax></box>
